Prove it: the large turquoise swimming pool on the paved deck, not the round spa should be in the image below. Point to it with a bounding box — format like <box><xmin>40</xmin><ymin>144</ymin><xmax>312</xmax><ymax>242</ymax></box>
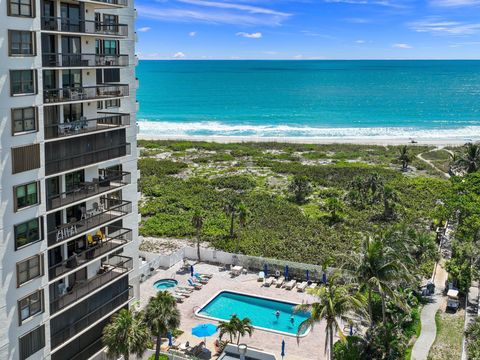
<box><xmin>196</xmin><ymin>291</ymin><xmax>310</xmax><ymax>336</ymax></box>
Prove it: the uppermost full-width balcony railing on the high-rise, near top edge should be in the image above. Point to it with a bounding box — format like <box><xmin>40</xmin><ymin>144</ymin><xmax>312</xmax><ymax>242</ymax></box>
<box><xmin>42</xmin><ymin>16</ymin><xmax>128</xmax><ymax>36</ymax></box>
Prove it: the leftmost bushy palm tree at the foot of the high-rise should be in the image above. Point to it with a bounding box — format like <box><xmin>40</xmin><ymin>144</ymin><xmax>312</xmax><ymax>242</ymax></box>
<box><xmin>102</xmin><ymin>309</ymin><xmax>151</xmax><ymax>360</ymax></box>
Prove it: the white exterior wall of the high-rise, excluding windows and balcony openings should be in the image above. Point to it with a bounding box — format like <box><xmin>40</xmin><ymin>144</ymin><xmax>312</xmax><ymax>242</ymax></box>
<box><xmin>0</xmin><ymin>0</ymin><xmax>139</xmax><ymax>360</ymax></box>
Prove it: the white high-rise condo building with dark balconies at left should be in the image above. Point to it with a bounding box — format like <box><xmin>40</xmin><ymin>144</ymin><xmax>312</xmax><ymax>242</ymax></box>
<box><xmin>0</xmin><ymin>0</ymin><xmax>138</xmax><ymax>360</ymax></box>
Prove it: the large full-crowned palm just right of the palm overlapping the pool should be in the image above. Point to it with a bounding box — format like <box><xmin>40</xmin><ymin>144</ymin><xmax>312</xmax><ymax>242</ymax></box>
<box><xmin>356</xmin><ymin>237</ymin><xmax>400</xmax><ymax>328</ymax></box>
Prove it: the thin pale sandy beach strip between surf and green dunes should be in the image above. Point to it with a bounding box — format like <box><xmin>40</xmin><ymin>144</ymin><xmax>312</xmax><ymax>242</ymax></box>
<box><xmin>137</xmin><ymin>134</ymin><xmax>474</xmax><ymax>147</ymax></box>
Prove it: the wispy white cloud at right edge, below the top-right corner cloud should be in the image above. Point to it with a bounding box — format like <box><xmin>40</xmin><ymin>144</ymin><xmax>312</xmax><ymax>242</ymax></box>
<box><xmin>408</xmin><ymin>17</ymin><xmax>480</xmax><ymax>36</ymax></box>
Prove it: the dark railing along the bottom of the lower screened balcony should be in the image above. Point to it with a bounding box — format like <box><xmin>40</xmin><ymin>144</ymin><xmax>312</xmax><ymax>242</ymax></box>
<box><xmin>51</xmin><ymin>286</ymin><xmax>133</xmax><ymax>349</ymax></box>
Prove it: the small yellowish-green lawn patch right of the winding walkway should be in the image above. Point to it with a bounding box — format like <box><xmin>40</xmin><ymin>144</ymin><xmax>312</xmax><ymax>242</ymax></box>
<box><xmin>428</xmin><ymin>310</ymin><xmax>465</xmax><ymax>360</ymax></box>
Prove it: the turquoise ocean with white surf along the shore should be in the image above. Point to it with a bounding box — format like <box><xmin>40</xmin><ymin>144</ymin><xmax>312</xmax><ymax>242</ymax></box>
<box><xmin>137</xmin><ymin>60</ymin><xmax>480</xmax><ymax>140</ymax></box>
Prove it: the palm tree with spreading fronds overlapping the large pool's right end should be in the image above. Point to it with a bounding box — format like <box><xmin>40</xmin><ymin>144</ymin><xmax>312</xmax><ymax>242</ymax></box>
<box><xmin>295</xmin><ymin>270</ymin><xmax>364</xmax><ymax>359</ymax></box>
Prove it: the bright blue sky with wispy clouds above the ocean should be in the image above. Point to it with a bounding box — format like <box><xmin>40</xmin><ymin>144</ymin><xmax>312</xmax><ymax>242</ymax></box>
<box><xmin>135</xmin><ymin>0</ymin><xmax>480</xmax><ymax>59</ymax></box>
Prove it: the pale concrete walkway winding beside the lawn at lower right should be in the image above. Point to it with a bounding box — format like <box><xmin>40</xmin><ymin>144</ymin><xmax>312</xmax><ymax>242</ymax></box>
<box><xmin>412</xmin><ymin>265</ymin><xmax>447</xmax><ymax>360</ymax></box>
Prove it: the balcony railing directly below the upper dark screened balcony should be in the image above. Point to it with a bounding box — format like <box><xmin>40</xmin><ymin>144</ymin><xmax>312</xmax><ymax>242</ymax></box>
<box><xmin>47</xmin><ymin>169</ymin><xmax>131</xmax><ymax>210</ymax></box>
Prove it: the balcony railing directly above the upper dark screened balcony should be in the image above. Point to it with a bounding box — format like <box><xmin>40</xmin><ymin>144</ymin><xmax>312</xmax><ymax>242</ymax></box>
<box><xmin>44</xmin><ymin>113</ymin><xmax>130</xmax><ymax>139</ymax></box>
